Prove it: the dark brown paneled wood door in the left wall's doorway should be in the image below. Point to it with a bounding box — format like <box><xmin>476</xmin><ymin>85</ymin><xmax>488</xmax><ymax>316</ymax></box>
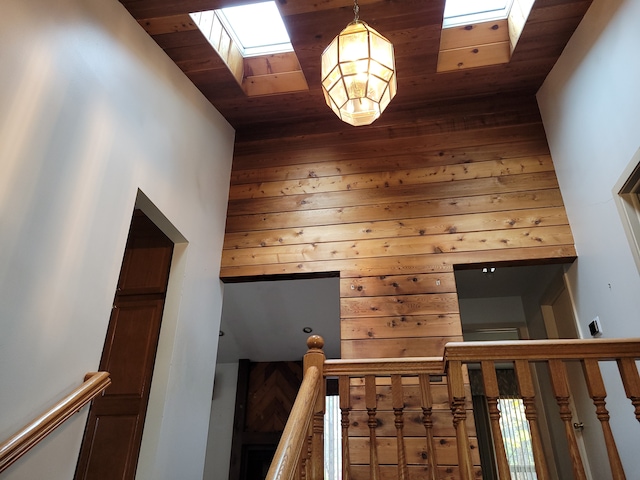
<box><xmin>75</xmin><ymin>211</ymin><xmax>173</xmax><ymax>480</ymax></box>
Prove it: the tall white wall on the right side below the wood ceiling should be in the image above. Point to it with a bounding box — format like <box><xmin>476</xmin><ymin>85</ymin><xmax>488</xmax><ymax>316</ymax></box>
<box><xmin>538</xmin><ymin>0</ymin><xmax>640</xmax><ymax>472</ymax></box>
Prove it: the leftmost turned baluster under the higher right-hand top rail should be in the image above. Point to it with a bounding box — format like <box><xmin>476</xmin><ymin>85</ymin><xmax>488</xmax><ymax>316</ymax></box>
<box><xmin>447</xmin><ymin>360</ymin><xmax>473</xmax><ymax>480</ymax></box>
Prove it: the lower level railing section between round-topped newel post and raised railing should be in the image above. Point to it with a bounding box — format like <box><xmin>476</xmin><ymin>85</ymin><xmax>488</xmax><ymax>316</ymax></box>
<box><xmin>324</xmin><ymin>357</ymin><xmax>444</xmax><ymax>480</ymax></box>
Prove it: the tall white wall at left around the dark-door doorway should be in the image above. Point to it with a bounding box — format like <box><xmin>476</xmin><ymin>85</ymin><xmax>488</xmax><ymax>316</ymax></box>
<box><xmin>0</xmin><ymin>0</ymin><xmax>234</xmax><ymax>480</ymax></box>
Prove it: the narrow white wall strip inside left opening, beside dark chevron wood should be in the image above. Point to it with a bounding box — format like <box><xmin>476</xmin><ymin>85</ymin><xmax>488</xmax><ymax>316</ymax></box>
<box><xmin>203</xmin><ymin>363</ymin><xmax>239</xmax><ymax>480</ymax></box>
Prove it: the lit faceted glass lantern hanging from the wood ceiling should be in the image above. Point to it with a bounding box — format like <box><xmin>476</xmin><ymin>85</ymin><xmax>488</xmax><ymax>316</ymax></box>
<box><xmin>322</xmin><ymin>0</ymin><xmax>396</xmax><ymax>126</ymax></box>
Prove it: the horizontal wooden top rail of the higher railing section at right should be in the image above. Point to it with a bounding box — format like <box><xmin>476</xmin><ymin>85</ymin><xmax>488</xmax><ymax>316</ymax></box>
<box><xmin>444</xmin><ymin>338</ymin><xmax>640</xmax><ymax>364</ymax></box>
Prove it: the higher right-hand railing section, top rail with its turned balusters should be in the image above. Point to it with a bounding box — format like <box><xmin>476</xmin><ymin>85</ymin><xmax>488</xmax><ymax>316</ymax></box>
<box><xmin>445</xmin><ymin>339</ymin><xmax>640</xmax><ymax>480</ymax></box>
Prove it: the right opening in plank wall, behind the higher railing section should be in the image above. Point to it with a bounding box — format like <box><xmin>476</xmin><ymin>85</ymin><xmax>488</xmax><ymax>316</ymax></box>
<box><xmin>455</xmin><ymin>264</ymin><xmax>575</xmax><ymax>479</ymax></box>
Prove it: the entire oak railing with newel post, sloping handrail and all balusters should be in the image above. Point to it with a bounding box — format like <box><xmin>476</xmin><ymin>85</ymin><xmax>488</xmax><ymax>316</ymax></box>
<box><xmin>267</xmin><ymin>336</ymin><xmax>640</xmax><ymax>480</ymax></box>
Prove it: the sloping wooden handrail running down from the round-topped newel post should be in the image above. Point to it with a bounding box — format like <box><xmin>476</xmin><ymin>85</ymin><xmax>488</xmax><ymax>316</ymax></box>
<box><xmin>266</xmin><ymin>367</ymin><xmax>321</xmax><ymax>480</ymax></box>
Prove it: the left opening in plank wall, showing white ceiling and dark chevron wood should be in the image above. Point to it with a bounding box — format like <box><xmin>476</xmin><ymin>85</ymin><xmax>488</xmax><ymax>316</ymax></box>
<box><xmin>205</xmin><ymin>272</ymin><xmax>340</xmax><ymax>480</ymax></box>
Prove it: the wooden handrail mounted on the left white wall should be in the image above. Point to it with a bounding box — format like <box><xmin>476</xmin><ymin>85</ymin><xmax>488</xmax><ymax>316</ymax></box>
<box><xmin>0</xmin><ymin>372</ymin><xmax>111</xmax><ymax>473</ymax></box>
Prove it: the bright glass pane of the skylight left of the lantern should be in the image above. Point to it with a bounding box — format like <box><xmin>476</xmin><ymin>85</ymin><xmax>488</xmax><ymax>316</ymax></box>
<box><xmin>216</xmin><ymin>2</ymin><xmax>293</xmax><ymax>57</ymax></box>
